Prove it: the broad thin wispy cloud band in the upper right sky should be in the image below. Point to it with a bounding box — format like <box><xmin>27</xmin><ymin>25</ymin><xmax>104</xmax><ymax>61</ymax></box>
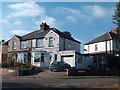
<box><xmin>55</xmin><ymin>5</ymin><xmax>114</xmax><ymax>22</ymax></box>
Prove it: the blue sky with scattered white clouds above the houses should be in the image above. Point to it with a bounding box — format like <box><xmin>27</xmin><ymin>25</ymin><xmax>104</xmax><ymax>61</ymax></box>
<box><xmin>0</xmin><ymin>1</ymin><xmax>116</xmax><ymax>50</ymax></box>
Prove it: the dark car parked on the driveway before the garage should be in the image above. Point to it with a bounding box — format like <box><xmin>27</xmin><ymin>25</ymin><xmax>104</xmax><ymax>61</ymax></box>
<box><xmin>49</xmin><ymin>61</ymin><xmax>71</xmax><ymax>71</ymax></box>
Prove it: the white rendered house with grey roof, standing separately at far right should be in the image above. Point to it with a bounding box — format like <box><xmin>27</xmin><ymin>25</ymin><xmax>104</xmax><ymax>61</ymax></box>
<box><xmin>84</xmin><ymin>29</ymin><xmax>120</xmax><ymax>55</ymax></box>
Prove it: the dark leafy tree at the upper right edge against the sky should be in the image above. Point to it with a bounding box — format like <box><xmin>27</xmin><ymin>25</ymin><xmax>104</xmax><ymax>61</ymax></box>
<box><xmin>112</xmin><ymin>1</ymin><xmax>120</xmax><ymax>42</ymax></box>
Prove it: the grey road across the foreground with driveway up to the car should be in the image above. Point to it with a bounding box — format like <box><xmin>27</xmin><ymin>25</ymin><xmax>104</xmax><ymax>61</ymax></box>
<box><xmin>2</xmin><ymin>70</ymin><xmax>119</xmax><ymax>89</ymax></box>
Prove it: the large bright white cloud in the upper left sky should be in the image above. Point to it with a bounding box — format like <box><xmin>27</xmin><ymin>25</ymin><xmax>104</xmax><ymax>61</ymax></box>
<box><xmin>7</xmin><ymin>2</ymin><xmax>46</xmax><ymax>18</ymax></box>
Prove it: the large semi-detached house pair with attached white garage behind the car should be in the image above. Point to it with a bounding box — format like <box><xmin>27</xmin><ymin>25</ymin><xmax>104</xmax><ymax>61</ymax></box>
<box><xmin>8</xmin><ymin>23</ymin><xmax>80</xmax><ymax>68</ymax></box>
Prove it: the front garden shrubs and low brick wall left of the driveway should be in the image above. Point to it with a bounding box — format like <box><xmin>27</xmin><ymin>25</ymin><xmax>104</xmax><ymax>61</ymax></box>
<box><xmin>1</xmin><ymin>60</ymin><xmax>42</xmax><ymax>76</ymax></box>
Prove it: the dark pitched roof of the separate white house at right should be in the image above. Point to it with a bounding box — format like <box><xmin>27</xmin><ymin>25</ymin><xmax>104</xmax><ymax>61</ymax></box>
<box><xmin>85</xmin><ymin>32</ymin><xmax>117</xmax><ymax>45</ymax></box>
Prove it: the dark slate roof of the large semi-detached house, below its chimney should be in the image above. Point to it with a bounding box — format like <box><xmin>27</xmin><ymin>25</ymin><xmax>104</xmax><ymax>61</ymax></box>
<box><xmin>19</xmin><ymin>28</ymin><xmax>80</xmax><ymax>43</ymax></box>
